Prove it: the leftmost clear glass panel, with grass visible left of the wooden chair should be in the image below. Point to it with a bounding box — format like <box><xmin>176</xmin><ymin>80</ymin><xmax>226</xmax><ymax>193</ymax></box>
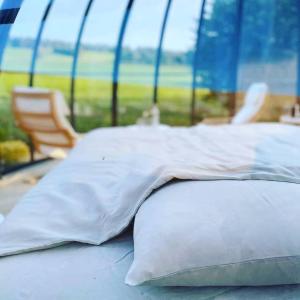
<box><xmin>0</xmin><ymin>0</ymin><xmax>48</xmax><ymax>171</ymax></box>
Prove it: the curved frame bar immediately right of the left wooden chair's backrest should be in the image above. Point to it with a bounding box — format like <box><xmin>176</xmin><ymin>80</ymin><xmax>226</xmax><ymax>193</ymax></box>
<box><xmin>70</xmin><ymin>0</ymin><xmax>94</xmax><ymax>128</ymax></box>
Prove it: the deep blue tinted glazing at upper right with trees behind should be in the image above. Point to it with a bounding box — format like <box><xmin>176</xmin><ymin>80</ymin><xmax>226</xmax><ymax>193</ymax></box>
<box><xmin>196</xmin><ymin>0</ymin><xmax>300</xmax><ymax>95</ymax></box>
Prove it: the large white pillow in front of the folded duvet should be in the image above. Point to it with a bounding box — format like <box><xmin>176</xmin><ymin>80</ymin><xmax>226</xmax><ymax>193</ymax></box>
<box><xmin>126</xmin><ymin>181</ymin><xmax>300</xmax><ymax>286</ymax></box>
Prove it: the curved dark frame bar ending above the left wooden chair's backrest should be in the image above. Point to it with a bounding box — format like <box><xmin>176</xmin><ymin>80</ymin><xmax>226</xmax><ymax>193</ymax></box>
<box><xmin>28</xmin><ymin>0</ymin><xmax>54</xmax><ymax>87</ymax></box>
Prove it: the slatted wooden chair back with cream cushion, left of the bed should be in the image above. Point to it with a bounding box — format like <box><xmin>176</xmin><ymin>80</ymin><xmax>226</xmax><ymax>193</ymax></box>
<box><xmin>12</xmin><ymin>87</ymin><xmax>78</xmax><ymax>157</ymax></box>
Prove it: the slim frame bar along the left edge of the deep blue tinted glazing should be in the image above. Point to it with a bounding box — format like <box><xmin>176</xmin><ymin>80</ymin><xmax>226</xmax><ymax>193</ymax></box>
<box><xmin>191</xmin><ymin>0</ymin><xmax>206</xmax><ymax>125</ymax></box>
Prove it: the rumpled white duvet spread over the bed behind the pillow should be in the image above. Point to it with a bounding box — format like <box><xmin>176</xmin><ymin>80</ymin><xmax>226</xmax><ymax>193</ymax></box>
<box><xmin>0</xmin><ymin>124</ymin><xmax>300</xmax><ymax>256</ymax></box>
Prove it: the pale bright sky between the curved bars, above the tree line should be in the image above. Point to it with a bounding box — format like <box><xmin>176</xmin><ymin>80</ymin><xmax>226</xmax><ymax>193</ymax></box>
<box><xmin>8</xmin><ymin>0</ymin><xmax>202</xmax><ymax>51</ymax></box>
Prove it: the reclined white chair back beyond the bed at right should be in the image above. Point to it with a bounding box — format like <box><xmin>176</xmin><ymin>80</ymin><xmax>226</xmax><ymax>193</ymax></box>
<box><xmin>231</xmin><ymin>82</ymin><xmax>268</xmax><ymax>124</ymax></box>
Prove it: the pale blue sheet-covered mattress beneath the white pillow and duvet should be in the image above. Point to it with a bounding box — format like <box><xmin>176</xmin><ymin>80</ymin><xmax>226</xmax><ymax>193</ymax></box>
<box><xmin>0</xmin><ymin>181</ymin><xmax>300</xmax><ymax>300</ymax></box>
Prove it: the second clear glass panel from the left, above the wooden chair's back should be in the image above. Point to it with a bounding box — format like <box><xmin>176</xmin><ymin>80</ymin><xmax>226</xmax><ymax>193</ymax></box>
<box><xmin>34</xmin><ymin>0</ymin><xmax>87</xmax><ymax>110</ymax></box>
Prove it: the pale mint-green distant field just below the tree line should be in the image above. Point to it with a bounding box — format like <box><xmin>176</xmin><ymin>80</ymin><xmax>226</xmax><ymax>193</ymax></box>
<box><xmin>2</xmin><ymin>47</ymin><xmax>192</xmax><ymax>88</ymax></box>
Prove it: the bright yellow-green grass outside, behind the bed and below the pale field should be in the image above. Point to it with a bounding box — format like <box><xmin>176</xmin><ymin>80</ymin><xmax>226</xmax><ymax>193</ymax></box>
<box><xmin>0</xmin><ymin>73</ymin><xmax>227</xmax><ymax>141</ymax></box>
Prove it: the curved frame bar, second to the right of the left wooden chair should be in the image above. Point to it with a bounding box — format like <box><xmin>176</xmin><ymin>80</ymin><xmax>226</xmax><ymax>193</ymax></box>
<box><xmin>111</xmin><ymin>0</ymin><xmax>134</xmax><ymax>126</ymax></box>
